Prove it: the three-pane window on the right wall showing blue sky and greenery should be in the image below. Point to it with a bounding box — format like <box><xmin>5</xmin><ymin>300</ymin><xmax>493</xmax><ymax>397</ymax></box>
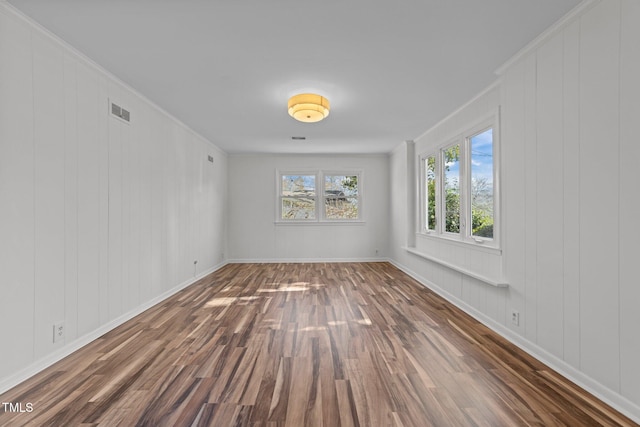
<box><xmin>420</xmin><ymin>120</ymin><xmax>498</xmax><ymax>246</ymax></box>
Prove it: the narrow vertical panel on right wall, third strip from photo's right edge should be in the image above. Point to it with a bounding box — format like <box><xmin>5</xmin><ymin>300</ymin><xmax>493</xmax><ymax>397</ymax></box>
<box><xmin>562</xmin><ymin>20</ymin><xmax>580</xmax><ymax>366</ymax></box>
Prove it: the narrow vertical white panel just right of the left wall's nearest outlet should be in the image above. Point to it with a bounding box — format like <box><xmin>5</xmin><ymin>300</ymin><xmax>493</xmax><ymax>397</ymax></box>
<box><xmin>63</xmin><ymin>55</ymin><xmax>78</xmax><ymax>341</ymax></box>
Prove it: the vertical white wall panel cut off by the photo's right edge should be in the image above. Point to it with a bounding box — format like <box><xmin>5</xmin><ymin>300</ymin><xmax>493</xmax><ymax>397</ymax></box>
<box><xmin>618</xmin><ymin>0</ymin><xmax>640</xmax><ymax>402</ymax></box>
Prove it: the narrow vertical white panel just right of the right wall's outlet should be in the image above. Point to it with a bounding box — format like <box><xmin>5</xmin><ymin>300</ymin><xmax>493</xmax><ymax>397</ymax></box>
<box><xmin>520</xmin><ymin>54</ymin><xmax>538</xmax><ymax>342</ymax></box>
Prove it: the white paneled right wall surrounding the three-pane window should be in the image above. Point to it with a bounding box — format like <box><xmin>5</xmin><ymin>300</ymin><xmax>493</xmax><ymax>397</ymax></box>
<box><xmin>390</xmin><ymin>0</ymin><xmax>640</xmax><ymax>421</ymax></box>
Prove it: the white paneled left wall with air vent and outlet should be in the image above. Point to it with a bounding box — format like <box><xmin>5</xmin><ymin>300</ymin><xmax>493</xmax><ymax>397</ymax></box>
<box><xmin>0</xmin><ymin>3</ymin><xmax>227</xmax><ymax>389</ymax></box>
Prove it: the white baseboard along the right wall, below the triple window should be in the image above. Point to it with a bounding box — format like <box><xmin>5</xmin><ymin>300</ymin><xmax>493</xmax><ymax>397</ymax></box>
<box><xmin>389</xmin><ymin>259</ymin><xmax>640</xmax><ymax>424</ymax></box>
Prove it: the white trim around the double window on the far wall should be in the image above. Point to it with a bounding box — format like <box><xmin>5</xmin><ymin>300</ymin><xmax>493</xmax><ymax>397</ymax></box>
<box><xmin>275</xmin><ymin>169</ymin><xmax>365</xmax><ymax>225</ymax></box>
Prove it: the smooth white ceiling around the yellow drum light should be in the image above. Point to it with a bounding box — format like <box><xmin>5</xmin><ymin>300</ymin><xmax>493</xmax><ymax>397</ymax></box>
<box><xmin>9</xmin><ymin>0</ymin><xmax>580</xmax><ymax>153</ymax></box>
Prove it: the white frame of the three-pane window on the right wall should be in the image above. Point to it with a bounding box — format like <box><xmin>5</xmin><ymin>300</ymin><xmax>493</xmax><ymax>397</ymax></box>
<box><xmin>418</xmin><ymin>111</ymin><xmax>501</xmax><ymax>249</ymax></box>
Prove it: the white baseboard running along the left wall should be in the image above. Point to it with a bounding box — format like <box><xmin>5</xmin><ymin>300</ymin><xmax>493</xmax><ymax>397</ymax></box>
<box><xmin>0</xmin><ymin>262</ymin><xmax>227</xmax><ymax>394</ymax></box>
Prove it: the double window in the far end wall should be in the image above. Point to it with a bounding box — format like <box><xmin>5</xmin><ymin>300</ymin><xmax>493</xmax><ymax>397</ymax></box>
<box><xmin>278</xmin><ymin>171</ymin><xmax>362</xmax><ymax>222</ymax></box>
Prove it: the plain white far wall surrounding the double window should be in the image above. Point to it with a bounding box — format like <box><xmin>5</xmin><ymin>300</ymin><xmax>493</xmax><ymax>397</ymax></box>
<box><xmin>228</xmin><ymin>155</ymin><xmax>389</xmax><ymax>261</ymax></box>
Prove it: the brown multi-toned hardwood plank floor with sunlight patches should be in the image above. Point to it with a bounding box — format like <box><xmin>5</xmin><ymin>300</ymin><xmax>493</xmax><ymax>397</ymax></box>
<box><xmin>0</xmin><ymin>263</ymin><xmax>636</xmax><ymax>427</ymax></box>
